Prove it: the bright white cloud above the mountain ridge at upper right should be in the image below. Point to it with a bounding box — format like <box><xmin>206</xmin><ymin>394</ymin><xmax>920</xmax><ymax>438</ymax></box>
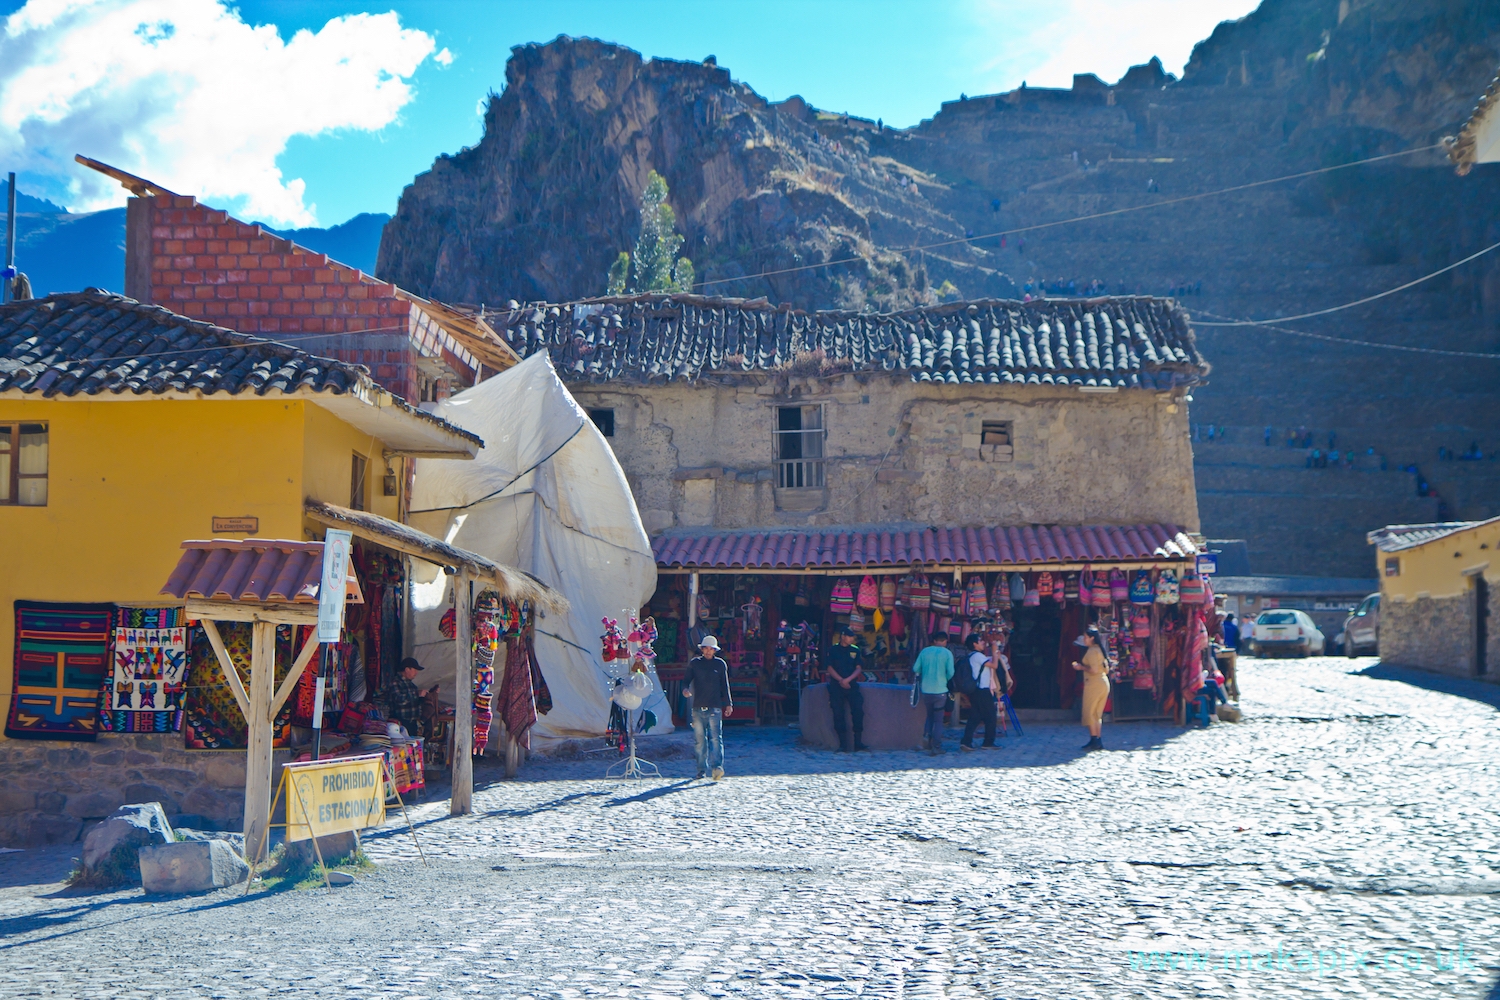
<box><xmin>975</xmin><ymin>0</ymin><xmax>1260</xmax><ymax>90</ymax></box>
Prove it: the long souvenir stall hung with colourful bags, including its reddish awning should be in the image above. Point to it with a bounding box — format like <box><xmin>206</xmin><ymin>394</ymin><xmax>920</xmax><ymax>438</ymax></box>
<box><xmin>644</xmin><ymin>525</ymin><xmax>1214</xmax><ymax>731</ymax></box>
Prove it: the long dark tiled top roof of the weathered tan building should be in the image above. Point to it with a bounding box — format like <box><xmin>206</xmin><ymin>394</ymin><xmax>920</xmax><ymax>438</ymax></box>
<box><xmin>486</xmin><ymin>295</ymin><xmax>1209</xmax><ymax>390</ymax></box>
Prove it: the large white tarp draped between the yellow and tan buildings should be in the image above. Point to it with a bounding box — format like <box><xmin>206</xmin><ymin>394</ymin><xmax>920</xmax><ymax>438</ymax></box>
<box><xmin>411</xmin><ymin>351</ymin><xmax>672</xmax><ymax>741</ymax></box>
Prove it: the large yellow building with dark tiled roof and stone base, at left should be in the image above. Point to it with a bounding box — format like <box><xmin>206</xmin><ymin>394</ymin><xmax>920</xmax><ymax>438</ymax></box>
<box><xmin>0</xmin><ymin>289</ymin><xmax>482</xmax><ymax>843</ymax></box>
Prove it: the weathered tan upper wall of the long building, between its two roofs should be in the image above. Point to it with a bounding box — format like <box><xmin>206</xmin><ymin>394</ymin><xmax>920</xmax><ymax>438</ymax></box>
<box><xmin>570</xmin><ymin>375</ymin><xmax>1199</xmax><ymax>534</ymax></box>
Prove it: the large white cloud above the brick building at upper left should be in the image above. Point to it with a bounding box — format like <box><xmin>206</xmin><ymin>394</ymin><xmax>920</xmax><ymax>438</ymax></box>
<box><xmin>0</xmin><ymin>0</ymin><xmax>435</xmax><ymax>225</ymax></box>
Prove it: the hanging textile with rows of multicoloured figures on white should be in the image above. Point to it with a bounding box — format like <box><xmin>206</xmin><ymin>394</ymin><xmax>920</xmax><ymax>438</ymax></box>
<box><xmin>99</xmin><ymin>607</ymin><xmax>188</xmax><ymax>733</ymax></box>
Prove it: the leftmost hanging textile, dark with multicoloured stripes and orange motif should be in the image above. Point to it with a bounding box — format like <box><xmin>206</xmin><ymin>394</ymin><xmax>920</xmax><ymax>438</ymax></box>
<box><xmin>5</xmin><ymin>601</ymin><xmax>114</xmax><ymax>742</ymax></box>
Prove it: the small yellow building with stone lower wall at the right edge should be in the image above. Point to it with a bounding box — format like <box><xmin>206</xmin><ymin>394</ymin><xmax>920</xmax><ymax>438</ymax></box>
<box><xmin>1368</xmin><ymin>517</ymin><xmax>1500</xmax><ymax>681</ymax></box>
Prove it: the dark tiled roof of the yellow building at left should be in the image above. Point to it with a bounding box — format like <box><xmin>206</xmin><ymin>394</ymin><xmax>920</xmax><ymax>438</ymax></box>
<box><xmin>0</xmin><ymin>288</ymin><xmax>480</xmax><ymax>444</ymax></box>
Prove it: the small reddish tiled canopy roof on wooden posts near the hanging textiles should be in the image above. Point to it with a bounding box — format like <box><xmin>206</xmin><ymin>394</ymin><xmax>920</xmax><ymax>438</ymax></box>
<box><xmin>161</xmin><ymin>538</ymin><xmax>349</xmax><ymax>604</ymax></box>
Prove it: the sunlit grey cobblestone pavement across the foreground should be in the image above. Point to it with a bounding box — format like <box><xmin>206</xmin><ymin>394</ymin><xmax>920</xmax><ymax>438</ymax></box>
<box><xmin>0</xmin><ymin>658</ymin><xmax>1500</xmax><ymax>1000</ymax></box>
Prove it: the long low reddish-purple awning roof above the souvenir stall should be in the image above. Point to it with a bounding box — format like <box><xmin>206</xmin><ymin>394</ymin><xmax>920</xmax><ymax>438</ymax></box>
<box><xmin>651</xmin><ymin>525</ymin><xmax>1197</xmax><ymax>571</ymax></box>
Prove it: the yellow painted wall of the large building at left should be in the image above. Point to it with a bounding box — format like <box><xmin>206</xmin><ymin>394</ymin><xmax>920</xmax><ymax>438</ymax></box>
<box><xmin>0</xmin><ymin>397</ymin><xmax>399</xmax><ymax>739</ymax></box>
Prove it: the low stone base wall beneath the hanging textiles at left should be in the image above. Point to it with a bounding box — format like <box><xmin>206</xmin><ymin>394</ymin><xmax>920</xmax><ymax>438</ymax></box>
<box><xmin>0</xmin><ymin>733</ymin><xmax>290</xmax><ymax>847</ymax></box>
